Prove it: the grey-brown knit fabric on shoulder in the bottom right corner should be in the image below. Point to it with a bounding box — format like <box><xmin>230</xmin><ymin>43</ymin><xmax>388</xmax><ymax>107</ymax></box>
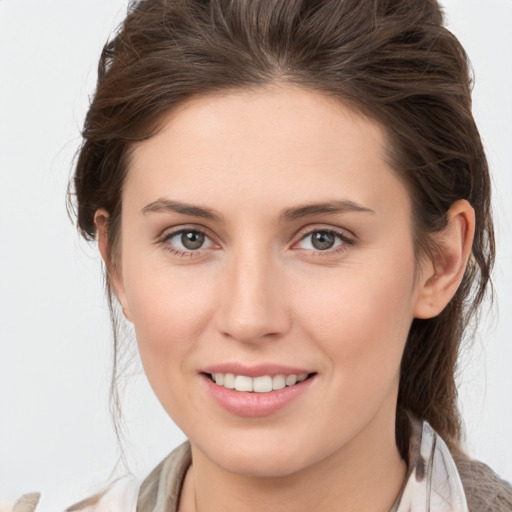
<box><xmin>453</xmin><ymin>453</ymin><xmax>512</xmax><ymax>512</ymax></box>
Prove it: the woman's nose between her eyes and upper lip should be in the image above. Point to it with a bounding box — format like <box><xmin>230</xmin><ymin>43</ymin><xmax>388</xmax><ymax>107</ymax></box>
<box><xmin>217</xmin><ymin>245</ymin><xmax>290</xmax><ymax>343</ymax></box>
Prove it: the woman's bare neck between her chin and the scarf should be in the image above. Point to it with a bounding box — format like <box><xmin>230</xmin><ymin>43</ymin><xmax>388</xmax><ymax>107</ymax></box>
<box><xmin>180</xmin><ymin>406</ymin><xmax>406</xmax><ymax>512</ymax></box>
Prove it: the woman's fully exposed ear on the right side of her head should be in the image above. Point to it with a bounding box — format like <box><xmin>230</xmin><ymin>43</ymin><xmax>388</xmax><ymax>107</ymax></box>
<box><xmin>414</xmin><ymin>199</ymin><xmax>475</xmax><ymax>318</ymax></box>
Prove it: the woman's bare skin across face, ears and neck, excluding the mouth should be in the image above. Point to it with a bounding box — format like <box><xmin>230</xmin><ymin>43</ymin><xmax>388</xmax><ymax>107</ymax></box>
<box><xmin>96</xmin><ymin>85</ymin><xmax>474</xmax><ymax>512</ymax></box>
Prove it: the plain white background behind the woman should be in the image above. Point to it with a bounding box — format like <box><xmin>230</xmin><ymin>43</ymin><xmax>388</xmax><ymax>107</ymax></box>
<box><xmin>0</xmin><ymin>0</ymin><xmax>512</xmax><ymax>512</ymax></box>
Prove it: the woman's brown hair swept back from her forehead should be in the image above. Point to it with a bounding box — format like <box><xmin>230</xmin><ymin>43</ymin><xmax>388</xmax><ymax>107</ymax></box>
<box><xmin>70</xmin><ymin>0</ymin><xmax>494</xmax><ymax>455</ymax></box>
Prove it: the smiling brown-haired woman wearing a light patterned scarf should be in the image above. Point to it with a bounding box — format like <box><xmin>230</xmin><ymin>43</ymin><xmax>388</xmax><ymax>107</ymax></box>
<box><xmin>11</xmin><ymin>0</ymin><xmax>512</xmax><ymax>512</ymax></box>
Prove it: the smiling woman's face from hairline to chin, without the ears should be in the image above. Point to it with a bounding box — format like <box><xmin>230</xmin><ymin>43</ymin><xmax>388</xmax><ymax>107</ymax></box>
<box><xmin>115</xmin><ymin>86</ymin><xmax>428</xmax><ymax>476</ymax></box>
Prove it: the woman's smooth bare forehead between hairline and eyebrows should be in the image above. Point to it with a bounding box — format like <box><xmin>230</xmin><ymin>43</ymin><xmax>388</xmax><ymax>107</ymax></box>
<box><xmin>123</xmin><ymin>85</ymin><xmax>407</xmax><ymax>218</ymax></box>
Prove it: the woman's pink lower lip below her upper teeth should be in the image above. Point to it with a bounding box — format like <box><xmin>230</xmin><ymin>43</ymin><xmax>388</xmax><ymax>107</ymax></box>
<box><xmin>201</xmin><ymin>374</ymin><xmax>316</xmax><ymax>418</ymax></box>
